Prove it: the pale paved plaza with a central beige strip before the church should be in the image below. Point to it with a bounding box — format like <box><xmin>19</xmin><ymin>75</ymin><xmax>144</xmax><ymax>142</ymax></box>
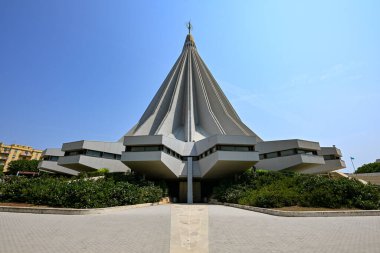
<box><xmin>0</xmin><ymin>205</ymin><xmax>380</xmax><ymax>253</ymax></box>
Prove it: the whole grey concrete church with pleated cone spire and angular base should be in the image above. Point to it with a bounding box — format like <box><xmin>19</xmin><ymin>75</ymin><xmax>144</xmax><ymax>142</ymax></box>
<box><xmin>39</xmin><ymin>24</ymin><xmax>345</xmax><ymax>203</ymax></box>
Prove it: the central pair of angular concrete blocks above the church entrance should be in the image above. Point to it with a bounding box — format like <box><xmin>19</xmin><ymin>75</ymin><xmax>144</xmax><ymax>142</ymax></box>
<box><xmin>121</xmin><ymin>135</ymin><xmax>259</xmax><ymax>179</ymax></box>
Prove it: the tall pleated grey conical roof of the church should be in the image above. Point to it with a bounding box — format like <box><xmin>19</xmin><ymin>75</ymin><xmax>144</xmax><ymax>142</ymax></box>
<box><xmin>126</xmin><ymin>33</ymin><xmax>261</xmax><ymax>142</ymax></box>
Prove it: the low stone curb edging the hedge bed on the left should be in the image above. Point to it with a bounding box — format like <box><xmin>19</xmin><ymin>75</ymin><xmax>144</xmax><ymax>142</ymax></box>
<box><xmin>0</xmin><ymin>202</ymin><xmax>166</xmax><ymax>215</ymax></box>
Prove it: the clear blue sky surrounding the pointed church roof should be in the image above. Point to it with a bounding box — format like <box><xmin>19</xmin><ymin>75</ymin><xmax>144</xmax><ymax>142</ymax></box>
<box><xmin>0</xmin><ymin>0</ymin><xmax>380</xmax><ymax>171</ymax></box>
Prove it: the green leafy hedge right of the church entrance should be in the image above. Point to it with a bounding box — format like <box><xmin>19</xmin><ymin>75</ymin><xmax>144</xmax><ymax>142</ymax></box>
<box><xmin>214</xmin><ymin>170</ymin><xmax>380</xmax><ymax>209</ymax></box>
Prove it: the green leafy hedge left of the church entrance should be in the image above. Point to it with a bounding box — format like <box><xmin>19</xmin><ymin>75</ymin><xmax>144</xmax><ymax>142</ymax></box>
<box><xmin>0</xmin><ymin>177</ymin><xmax>164</xmax><ymax>208</ymax></box>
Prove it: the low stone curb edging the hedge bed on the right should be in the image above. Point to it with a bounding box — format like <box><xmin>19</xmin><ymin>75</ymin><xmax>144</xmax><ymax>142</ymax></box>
<box><xmin>213</xmin><ymin>202</ymin><xmax>380</xmax><ymax>217</ymax></box>
